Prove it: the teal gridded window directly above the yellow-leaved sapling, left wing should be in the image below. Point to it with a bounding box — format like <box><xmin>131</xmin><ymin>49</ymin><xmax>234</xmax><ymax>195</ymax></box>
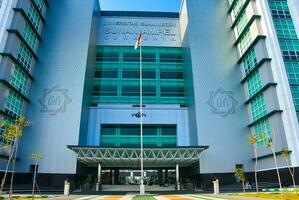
<box><xmin>5</xmin><ymin>91</ymin><xmax>24</xmax><ymax>116</ymax></box>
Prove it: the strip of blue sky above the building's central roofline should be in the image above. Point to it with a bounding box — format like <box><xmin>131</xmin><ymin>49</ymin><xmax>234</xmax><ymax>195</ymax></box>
<box><xmin>100</xmin><ymin>0</ymin><xmax>181</xmax><ymax>12</ymax></box>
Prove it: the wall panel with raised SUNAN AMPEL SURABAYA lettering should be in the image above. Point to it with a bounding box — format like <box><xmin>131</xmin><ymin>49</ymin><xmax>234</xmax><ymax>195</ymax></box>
<box><xmin>98</xmin><ymin>17</ymin><xmax>181</xmax><ymax>47</ymax></box>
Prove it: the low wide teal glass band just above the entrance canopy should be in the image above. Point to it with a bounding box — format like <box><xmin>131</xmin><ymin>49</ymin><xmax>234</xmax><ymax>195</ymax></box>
<box><xmin>101</xmin><ymin>125</ymin><xmax>176</xmax><ymax>148</ymax></box>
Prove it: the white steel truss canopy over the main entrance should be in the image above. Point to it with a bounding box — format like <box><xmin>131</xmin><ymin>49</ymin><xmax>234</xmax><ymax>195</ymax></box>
<box><xmin>68</xmin><ymin>145</ymin><xmax>208</xmax><ymax>168</ymax></box>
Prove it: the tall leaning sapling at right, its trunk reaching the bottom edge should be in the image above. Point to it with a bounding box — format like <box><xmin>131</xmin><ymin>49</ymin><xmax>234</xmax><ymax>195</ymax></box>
<box><xmin>259</xmin><ymin>130</ymin><xmax>284</xmax><ymax>199</ymax></box>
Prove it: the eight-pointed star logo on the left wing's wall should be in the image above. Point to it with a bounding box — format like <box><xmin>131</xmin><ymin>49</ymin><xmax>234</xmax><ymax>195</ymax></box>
<box><xmin>38</xmin><ymin>86</ymin><xmax>72</xmax><ymax>115</ymax></box>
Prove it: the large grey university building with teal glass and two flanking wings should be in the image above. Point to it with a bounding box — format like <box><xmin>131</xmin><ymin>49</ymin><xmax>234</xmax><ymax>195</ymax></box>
<box><xmin>0</xmin><ymin>0</ymin><xmax>299</xmax><ymax>191</ymax></box>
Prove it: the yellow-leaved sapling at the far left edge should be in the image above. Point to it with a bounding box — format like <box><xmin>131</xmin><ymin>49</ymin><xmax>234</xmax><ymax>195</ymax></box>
<box><xmin>0</xmin><ymin>116</ymin><xmax>30</xmax><ymax>199</ymax></box>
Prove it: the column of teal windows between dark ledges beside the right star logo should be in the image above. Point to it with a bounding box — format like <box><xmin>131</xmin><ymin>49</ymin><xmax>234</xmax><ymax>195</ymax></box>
<box><xmin>232</xmin><ymin>0</ymin><xmax>271</xmax><ymax>139</ymax></box>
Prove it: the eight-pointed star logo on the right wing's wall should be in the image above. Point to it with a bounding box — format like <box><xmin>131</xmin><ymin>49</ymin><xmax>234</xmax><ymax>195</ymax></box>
<box><xmin>207</xmin><ymin>87</ymin><xmax>238</xmax><ymax>117</ymax></box>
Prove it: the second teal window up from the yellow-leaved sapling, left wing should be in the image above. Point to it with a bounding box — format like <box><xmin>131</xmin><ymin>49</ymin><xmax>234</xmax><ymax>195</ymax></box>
<box><xmin>10</xmin><ymin>65</ymin><xmax>28</xmax><ymax>94</ymax></box>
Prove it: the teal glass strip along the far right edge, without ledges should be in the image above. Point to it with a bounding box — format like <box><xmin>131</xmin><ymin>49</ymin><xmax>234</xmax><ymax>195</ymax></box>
<box><xmin>268</xmin><ymin>0</ymin><xmax>299</xmax><ymax>119</ymax></box>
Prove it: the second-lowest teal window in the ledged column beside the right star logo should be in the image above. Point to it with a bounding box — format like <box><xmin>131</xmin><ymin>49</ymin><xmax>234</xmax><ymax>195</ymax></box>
<box><xmin>250</xmin><ymin>93</ymin><xmax>267</xmax><ymax>121</ymax></box>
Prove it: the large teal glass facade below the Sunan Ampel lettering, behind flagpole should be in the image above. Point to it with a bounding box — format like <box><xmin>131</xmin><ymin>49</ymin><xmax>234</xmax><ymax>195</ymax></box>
<box><xmin>92</xmin><ymin>46</ymin><xmax>186</xmax><ymax>105</ymax></box>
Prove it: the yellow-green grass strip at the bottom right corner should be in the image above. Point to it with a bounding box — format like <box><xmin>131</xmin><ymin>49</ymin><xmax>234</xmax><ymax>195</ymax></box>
<box><xmin>232</xmin><ymin>192</ymin><xmax>299</xmax><ymax>200</ymax></box>
